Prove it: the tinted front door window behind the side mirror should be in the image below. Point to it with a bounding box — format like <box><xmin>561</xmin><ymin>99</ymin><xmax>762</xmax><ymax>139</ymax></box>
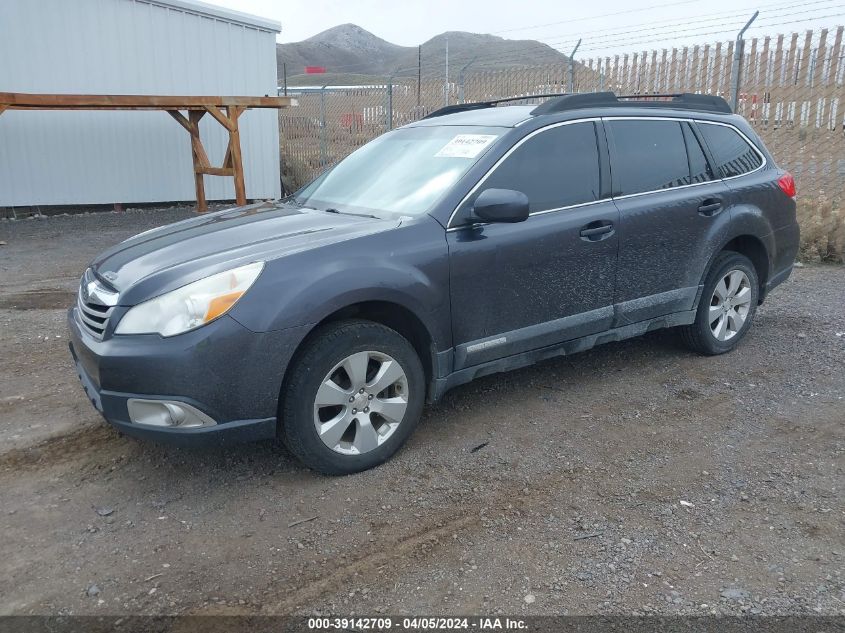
<box><xmin>477</xmin><ymin>122</ymin><xmax>600</xmax><ymax>213</ymax></box>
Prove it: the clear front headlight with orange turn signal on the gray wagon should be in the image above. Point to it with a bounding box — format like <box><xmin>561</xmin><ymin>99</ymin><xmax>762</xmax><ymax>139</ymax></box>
<box><xmin>115</xmin><ymin>262</ymin><xmax>264</xmax><ymax>336</ymax></box>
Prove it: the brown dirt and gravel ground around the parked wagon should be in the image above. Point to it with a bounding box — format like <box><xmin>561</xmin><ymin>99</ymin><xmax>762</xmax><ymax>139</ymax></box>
<box><xmin>0</xmin><ymin>209</ymin><xmax>845</xmax><ymax>615</ymax></box>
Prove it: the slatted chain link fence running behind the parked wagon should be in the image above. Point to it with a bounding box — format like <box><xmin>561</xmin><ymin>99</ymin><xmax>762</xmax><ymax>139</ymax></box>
<box><xmin>280</xmin><ymin>27</ymin><xmax>845</xmax><ymax>261</ymax></box>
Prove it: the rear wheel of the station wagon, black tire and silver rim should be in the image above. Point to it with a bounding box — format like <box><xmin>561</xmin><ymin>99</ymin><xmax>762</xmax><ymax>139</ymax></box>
<box><xmin>680</xmin><ymin>251</ymin><xmax>760</xmax><ymax>356</ymax></box>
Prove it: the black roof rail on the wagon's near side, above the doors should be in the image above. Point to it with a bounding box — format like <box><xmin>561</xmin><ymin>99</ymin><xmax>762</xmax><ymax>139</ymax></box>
<box><xmin>531</xmin><ymin>92</ymin><xmax>733</xmax><ymax>116</ymax></box>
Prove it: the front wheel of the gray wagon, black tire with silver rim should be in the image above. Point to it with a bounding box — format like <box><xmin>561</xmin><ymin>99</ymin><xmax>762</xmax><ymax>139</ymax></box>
<box><xmin>279</xmin><ymin>320</ymin><xmax>425</xmax><ymax>475</ymax></box>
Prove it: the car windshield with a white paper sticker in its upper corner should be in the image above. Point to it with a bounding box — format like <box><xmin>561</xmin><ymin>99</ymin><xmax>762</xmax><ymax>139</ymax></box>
<box><xmin>294</xmin><ymin>126</ymin><xmax>505</xmax><ymax>216</ymax></box>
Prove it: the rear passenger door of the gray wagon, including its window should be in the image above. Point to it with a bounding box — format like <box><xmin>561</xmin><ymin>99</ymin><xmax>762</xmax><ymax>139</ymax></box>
<box><xmin>605</xmin><ymin>117</ymin><xmax>730</xmax><ymax>326</ymax></box>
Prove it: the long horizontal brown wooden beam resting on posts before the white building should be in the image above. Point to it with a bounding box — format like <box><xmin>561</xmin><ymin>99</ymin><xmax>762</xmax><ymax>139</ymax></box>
<box><xmin>0</xmin><ymin>92</ymin><xmax>296</xmax><ymax>110</ymax></box>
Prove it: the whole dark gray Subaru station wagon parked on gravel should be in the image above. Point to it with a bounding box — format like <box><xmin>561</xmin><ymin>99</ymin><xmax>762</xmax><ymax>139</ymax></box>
<box><xmin>69</xmin><ymin>93</ymin><xmax>798</xmax><ymax>474</ymax></box>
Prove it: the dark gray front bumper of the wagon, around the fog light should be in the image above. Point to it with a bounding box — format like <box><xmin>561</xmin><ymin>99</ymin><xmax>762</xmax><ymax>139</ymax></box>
<box><xmin>68</xmin><ymin>308</ymin><xmax>308</xmax><ymax>446</ymax></box>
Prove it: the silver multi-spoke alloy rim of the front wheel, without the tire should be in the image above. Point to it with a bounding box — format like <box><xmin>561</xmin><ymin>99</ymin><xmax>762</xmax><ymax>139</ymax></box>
<box><xmin>314</xmin><ymin>351</ymin><xmax>408</xmax><ymax>455</ymax></box>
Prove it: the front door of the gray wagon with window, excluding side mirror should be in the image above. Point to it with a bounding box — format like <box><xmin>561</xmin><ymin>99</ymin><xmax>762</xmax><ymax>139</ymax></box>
<box><xmin>447</xmin><ymin>121</ymin><xmax>618</xmax><ymax>370</ymax></box>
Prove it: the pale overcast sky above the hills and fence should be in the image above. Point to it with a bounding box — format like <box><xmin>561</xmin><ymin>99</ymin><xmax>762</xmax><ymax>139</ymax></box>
<box><xmin>206</xmin><ymin>0</ymin><xmax>845</xmax><ymax>57</ymax></box>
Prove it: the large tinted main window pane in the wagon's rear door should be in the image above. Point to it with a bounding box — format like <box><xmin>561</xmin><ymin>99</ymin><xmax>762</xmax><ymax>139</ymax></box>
<box><xmin>606</xmin><ymin>120</ymin><xmax>692</xmax><ymax>195</ymax></box>
